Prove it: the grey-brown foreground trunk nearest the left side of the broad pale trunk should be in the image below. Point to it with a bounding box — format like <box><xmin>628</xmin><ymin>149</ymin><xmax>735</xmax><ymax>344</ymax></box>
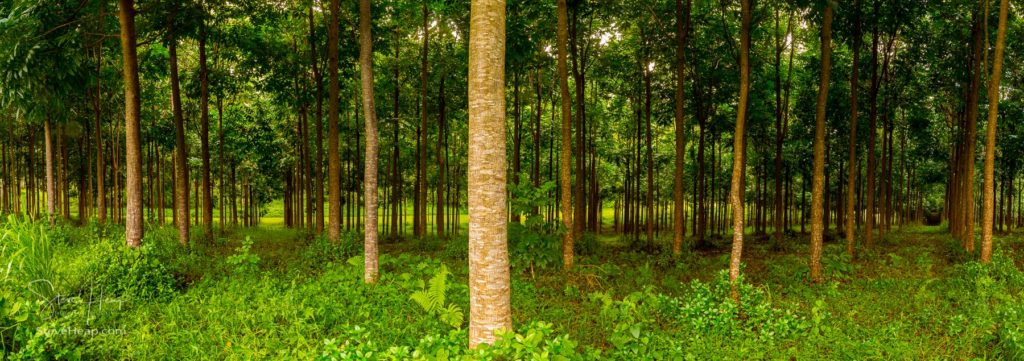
<box><xmin>358</xmin><ymin>0</ymin><xmax>378</xmax><ymax>283</ymax></box>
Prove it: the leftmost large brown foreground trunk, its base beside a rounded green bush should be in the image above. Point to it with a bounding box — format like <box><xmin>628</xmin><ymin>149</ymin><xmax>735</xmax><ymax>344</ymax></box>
<box><xmin>118</xmin><ymin>0</ymin><xmax>143</xmax><ymax>247</ymax></box>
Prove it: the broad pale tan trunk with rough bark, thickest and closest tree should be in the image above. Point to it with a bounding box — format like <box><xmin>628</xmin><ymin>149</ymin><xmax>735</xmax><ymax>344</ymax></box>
<box><xmin>468</xmin><ymin>0</ymin><xmax>512</xmax><ymax>343</ymax></box>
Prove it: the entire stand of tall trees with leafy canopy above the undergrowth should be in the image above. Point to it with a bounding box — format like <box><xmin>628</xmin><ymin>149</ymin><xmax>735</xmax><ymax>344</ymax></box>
<box><xmin>0</xmin><ymin>0</ymin><xmax>1024</xmax><ymax>346</ymax></box>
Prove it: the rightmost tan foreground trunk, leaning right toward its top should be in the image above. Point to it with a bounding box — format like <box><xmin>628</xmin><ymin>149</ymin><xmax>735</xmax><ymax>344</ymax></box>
<box><xmin>981</xmin><ymin>0</ymin><xmax>1009</xmax><ymax>263</ymax></box>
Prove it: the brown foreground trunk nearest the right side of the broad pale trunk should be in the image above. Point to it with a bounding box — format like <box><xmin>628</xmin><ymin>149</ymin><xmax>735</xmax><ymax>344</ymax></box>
<box><xmin>557</xmin><ymin>0</ymin><xmax>575</xmax><ymax>270</ymax></box>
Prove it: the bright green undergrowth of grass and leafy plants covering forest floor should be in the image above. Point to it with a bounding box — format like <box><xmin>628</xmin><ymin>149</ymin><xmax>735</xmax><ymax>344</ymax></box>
<box><xmin>4</xmin><ymin>218</ymin><xmax>1024</xmax><ymax>360</ymax></box>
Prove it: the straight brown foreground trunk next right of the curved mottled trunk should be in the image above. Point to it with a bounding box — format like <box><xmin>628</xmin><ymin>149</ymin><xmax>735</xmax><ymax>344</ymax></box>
<box><xmin>811</xmin><ymin>3</ymin><xmax>833</xmax><ymax>283</ymax></box>
